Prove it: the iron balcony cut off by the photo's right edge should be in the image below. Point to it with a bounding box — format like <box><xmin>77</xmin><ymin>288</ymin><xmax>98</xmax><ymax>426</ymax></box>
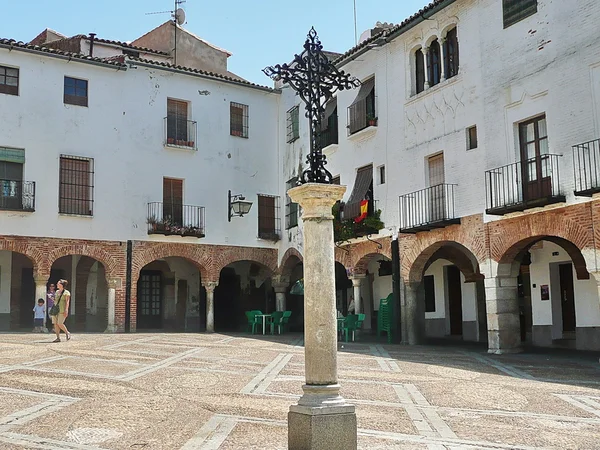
<box><xmin>573</xmin><ymin>139</ymin><xmax>600</xmax><ymax>197</ymax></box>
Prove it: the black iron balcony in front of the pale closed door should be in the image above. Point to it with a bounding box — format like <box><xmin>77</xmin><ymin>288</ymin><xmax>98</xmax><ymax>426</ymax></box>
<box><xmin>400</xmin><ymin>184</ymin><xmax>460</xmax><ymax>233</ymax></box>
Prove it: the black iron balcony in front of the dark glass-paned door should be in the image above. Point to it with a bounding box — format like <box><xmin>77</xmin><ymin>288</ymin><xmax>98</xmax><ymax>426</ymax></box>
<box><xmin>485</xmin><ymin>155</ymin><xmax>565</xmax><ymax>215</ymax></box>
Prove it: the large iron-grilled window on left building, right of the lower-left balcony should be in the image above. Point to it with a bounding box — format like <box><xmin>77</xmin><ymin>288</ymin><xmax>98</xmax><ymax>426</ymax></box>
<box><xmin>58</xmin><ymin>155</ymin><xmax>94</xmax><ymax>216</ymax></box>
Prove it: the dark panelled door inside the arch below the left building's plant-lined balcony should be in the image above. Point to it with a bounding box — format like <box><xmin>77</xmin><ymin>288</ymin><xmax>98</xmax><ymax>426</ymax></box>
<box><xmin>137</xmin><ymin>270</ymin><xmax>162</xmax><ymax>329</ymax></box>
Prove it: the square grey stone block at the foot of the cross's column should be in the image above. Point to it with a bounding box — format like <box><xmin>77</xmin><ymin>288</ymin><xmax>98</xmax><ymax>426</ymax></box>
<box><xmin>288</xmin><ymin>405</ymin><xmax>357</xmax><ymax>450</ymax></box>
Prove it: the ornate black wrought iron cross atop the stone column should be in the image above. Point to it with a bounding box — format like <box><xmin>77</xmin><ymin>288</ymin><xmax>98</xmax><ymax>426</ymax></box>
<box><xmin>263</xmin><ymin>27</ymin><xmax>360</xmax><ymax>183</ymax></box>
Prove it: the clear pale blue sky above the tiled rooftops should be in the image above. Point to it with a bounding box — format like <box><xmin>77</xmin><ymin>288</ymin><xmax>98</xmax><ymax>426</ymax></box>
<box><xmin>0</xmin><ymin>0</ymin><xmax>429</xmax><ymax>85</ymax></box>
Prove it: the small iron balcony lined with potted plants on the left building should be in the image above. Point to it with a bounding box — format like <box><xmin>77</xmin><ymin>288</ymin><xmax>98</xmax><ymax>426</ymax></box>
<box><xmin>147</xmin><ymin>202</ymin><xmax>205</xmax><ymax>238</ymax></box>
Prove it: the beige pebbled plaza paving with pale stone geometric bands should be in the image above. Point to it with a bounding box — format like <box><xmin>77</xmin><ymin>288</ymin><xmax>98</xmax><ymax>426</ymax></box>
<box><xmin>0</xmin><ymin>334</ymin><xmax>600</xmax><ymax>450</ymax></box>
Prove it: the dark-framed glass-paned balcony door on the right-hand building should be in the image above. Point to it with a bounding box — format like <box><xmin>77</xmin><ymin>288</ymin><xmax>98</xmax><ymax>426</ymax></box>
<box><xmin>519</xmin><ymin>116</ymin><xmax>552</xmax><ymax>201</ymax></box>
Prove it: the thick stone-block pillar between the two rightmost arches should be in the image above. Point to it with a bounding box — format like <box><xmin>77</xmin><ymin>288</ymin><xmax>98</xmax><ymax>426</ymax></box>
<box><xmin>485</xmin><ymin>277</ymin><xmax>521</xmax><ymax>355</ymax></box>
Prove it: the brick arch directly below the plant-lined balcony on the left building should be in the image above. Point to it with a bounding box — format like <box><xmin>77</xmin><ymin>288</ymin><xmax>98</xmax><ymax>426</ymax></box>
<box><xmin>131</xmin><ymin>243</ymin><xmax>211</xmax><ymax>283</ymax></box>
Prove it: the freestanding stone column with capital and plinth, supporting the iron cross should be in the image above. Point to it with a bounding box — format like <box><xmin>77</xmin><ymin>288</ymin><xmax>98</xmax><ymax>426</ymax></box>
<box><xmin>288</xmin><ymin>183</ymin><xmax>357</xmax><ymax>450</ymax></box>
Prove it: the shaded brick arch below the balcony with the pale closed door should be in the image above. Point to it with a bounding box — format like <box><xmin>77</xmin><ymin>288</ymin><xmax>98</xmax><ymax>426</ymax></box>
<box><xmin>403</xmin><ymin>241</ymin><xmax>482</xmax><ymax>283</ymax></box>
